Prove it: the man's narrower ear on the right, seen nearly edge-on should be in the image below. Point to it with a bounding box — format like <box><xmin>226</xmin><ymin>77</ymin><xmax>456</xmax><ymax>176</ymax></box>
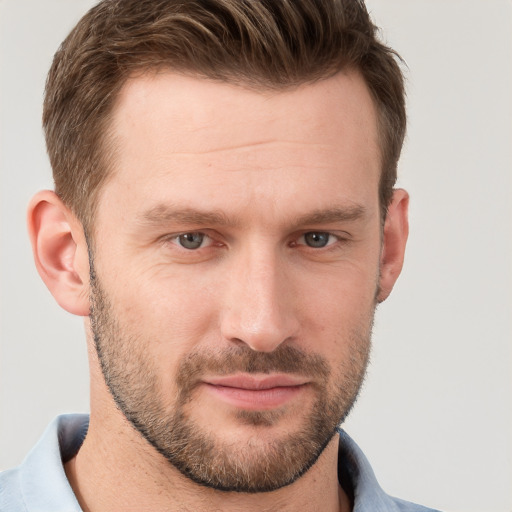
<box><xmin>377</xmin><ymin>189</ymin><xmax>409</xmax><ymax>302</ymax></box>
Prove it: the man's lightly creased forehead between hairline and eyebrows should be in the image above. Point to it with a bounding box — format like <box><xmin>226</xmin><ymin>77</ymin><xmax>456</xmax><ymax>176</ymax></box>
<box><xmin>100</xmin><ymin>72</ymin><xmax>380</xmax><ymax>226</ymax></box>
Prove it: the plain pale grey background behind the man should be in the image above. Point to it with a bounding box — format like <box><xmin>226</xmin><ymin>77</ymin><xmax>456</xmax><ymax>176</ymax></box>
<box><xmin>0</xmin><ymin>0</ymin><xmax>512</xmax><ymax>512</ymax></box>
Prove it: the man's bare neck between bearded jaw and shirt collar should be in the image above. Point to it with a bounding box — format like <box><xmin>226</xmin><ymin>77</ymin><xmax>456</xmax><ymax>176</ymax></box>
<box><xmin>65</xmin><ymin>413</ymin><xmax>350</xmax><ymax>512</ymax></box>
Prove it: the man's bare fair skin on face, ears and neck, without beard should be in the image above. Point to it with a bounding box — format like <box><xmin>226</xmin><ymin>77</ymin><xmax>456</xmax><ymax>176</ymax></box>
<box><xmin>29</xmin><ymin>71</ymin><xmax>408</xmax><ymax>512</ymax></box>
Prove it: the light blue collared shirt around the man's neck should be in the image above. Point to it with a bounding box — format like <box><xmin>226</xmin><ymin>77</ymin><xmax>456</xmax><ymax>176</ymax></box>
<box><xmin>0</xmin><ymin>414</ymin><xmax>435</xmax><ymax>512</ymax></box>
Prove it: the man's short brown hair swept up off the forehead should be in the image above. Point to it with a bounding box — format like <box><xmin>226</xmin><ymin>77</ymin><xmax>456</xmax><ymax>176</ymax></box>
<box><xmin>43</xmin><ymin>0</ymin><xmax>406</xmax><ymax>226</ymax></box>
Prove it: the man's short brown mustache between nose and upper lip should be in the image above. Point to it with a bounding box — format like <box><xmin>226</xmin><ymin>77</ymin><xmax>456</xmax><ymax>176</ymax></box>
<box><xmin>176</xmin><ymin>345</ymin><xmax>331</xmax><ymax>391</ymax></box>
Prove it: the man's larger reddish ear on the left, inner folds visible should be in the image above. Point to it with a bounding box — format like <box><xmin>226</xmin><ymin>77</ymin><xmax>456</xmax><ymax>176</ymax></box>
<box><xmin>27</xmin><ymin>190</ymin><xmax>89</xmax><ymax>316</ymax></box>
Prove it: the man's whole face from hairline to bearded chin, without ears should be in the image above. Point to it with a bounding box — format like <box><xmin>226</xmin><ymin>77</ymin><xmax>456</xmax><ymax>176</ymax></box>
<box><xmin>91</xmin><ymin>73</ymin><xmax>381</xmax><ymax>492</ymax></box>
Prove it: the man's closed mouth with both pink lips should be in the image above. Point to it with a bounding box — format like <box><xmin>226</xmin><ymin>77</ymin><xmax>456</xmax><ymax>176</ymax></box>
<box><xmin>203</xmin><ymin>374</ymin><xmax>308</xmax><ymax>411</ymax></box>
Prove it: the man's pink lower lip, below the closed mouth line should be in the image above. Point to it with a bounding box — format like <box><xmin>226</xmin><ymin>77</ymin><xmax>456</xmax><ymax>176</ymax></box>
<box><xmin>205</xmin><ymin>384</ymin><xmax>306</xmax><ymax>411</ymax></box>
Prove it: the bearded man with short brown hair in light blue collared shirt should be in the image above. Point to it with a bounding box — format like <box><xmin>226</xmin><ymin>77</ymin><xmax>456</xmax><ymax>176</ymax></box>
<box><xmin>0</xmin><ymin>0</ymin><xmax>440</xmax><ymax>512</ymax></box>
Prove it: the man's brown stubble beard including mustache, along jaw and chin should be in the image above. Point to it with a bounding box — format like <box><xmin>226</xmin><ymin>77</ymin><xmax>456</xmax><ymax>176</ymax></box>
<box><xmin>90</xmin><ymin>259</ymin><xmax>373</xmax><ymax>493</ymax></box>
